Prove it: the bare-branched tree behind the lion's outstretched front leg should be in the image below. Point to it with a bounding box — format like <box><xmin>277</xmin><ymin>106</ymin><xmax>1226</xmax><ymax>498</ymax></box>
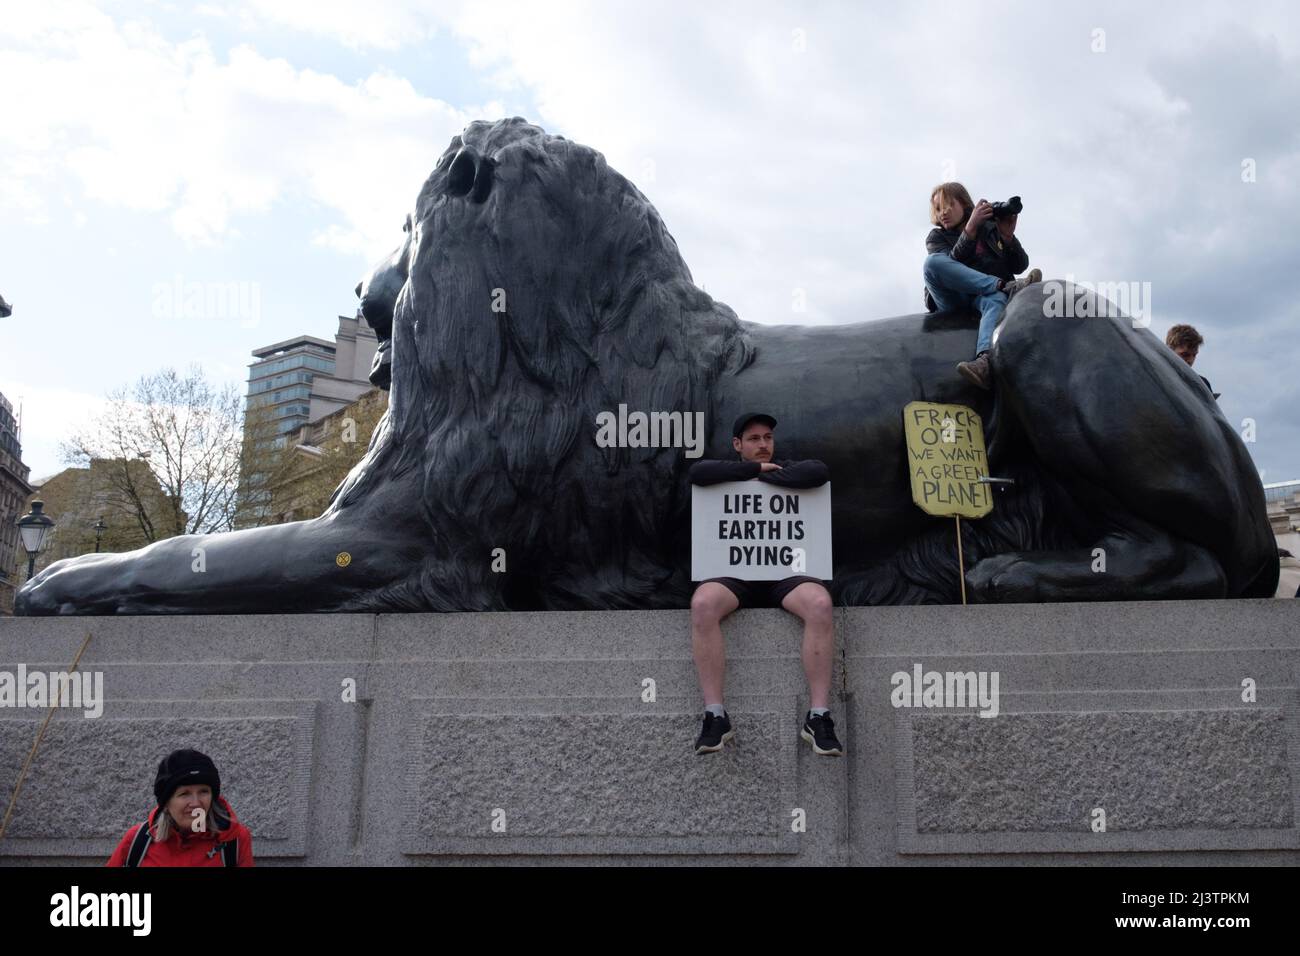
<box><xmin>61</xmin><ymin>365</ymin><xmax>242</xmax><ymax>541</ymax></box>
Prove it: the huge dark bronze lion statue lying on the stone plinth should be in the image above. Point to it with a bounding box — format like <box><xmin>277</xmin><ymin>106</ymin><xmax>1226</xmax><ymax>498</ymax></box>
<box><xmin>17</xmin><ymin>117</ymin><xmax>1278</xmax><ymax>614</ymax></box>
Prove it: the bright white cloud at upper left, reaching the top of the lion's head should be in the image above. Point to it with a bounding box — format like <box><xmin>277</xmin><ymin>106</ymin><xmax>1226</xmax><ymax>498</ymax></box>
<box><xmin>0</xmin><ymin>4</ymin><xmax>488</xmax><ymax>258</ymax></box>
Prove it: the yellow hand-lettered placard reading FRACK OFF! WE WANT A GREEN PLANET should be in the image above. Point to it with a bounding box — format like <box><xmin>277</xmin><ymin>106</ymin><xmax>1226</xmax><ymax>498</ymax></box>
<box><xmin>902</xmin><ymin>402</ymin><xmax>993</xmax><ymax>518</ymax></box>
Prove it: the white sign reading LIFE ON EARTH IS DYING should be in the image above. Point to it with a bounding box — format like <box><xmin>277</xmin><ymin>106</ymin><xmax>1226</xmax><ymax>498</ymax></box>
<box><xmin>690</xmin><ymin>481</ymin><xmax>832</xmax><ymax>581</ymax></box>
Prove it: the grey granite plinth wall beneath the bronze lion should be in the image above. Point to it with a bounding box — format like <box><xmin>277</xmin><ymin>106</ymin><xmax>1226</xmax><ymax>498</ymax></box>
<box><xmin>0</xmin><ymin>601</ymin><xmax>1300</xmax><ymax>865</ymax></box>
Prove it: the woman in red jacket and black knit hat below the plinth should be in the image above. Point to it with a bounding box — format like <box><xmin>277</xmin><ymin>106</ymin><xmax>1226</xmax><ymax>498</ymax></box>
<box><xmin>108</xmin><ymin>750</ymin><xmax>252</xmax><ymax>866</ymax></box>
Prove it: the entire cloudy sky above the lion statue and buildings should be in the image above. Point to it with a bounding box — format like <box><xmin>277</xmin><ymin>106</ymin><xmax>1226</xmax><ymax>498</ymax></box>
<box><xmin>0</xmin><ymin>0</ymin><xmax>1300</xmax><ymax>481</ymax></box>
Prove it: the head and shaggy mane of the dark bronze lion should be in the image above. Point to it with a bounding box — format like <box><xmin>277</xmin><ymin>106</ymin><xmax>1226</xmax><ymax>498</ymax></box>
<box><xmin>326</xmin><ymin>117</ymin><xmax>751</xmax><ymax>606</ymax></box>
